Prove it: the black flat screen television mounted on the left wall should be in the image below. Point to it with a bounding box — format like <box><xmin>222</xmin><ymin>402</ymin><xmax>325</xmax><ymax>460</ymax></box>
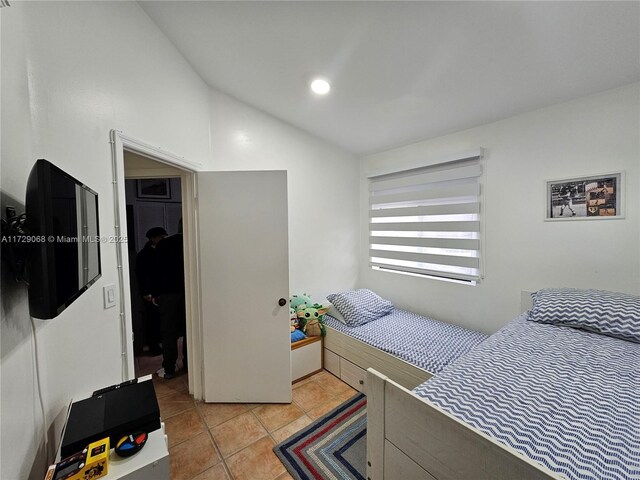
<box><xmin>25</xmin><ymin>160</ymin><xmax>101</xmax><ymax>319</ymax></box>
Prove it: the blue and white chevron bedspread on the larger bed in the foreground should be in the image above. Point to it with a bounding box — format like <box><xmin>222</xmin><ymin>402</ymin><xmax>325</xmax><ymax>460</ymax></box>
<box><xmin>414</xmin><ymin>316</ymin><xmax>640</xmax><ymax>480</ymax></box>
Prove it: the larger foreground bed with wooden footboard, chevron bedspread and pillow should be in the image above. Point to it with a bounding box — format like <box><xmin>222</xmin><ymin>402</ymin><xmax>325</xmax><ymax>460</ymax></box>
<box><xmin>367</xmin><ymin>289</ymin><xmax>640</xmax><ymax>480</ymax></box>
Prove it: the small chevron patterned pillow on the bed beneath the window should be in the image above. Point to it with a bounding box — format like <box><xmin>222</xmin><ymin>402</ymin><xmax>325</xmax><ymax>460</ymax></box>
<box><xmin>327</xmin><ymin>288</ymin><xmax>393</xmax><ymax>327</ymax></box>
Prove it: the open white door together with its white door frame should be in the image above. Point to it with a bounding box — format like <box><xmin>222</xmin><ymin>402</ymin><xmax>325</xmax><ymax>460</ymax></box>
<box><xmin>111</xmin><ymin>130</ymin><xmax>291</xmax><ymax>403</ymax></box>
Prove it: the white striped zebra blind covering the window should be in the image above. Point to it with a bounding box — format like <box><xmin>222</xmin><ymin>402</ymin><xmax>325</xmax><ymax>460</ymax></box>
<box><xmin>369</xmin><ymin>154</ymin><xmax>482</xmax><ymax>285</ymax></box>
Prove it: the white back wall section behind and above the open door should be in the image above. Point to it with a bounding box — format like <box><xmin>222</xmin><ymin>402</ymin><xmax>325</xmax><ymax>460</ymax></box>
<box><xmin>211</xmin><ymin>91</ymin><xmax>359</xmax><ymax>303</ymax></box>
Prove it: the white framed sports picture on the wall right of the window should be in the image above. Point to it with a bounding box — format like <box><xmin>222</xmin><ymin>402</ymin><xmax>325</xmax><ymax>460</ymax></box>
<box><xmin>545</xmin><ymin>172</ymin><xmax>624</xmax><ymax>220</ymax></box>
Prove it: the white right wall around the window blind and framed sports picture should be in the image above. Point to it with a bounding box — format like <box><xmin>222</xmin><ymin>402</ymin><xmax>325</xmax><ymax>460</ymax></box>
<box><xmin>359</xmin><ymin>84</ymin><xmax>640</xmax><ymax>332</ymax></box>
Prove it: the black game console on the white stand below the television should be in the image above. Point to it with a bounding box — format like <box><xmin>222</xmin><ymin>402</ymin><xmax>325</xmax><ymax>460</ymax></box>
<box><xmin>60</xmin><ymin>380</ymin><xmax>160</xmax><ymax>457</ymax></box>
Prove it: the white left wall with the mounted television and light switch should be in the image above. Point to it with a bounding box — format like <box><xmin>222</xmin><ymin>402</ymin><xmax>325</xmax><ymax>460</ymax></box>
<box><xmin>0</xmin><ymin>2</ymin><xmax>209</xmax><ymax>480</ymax></box>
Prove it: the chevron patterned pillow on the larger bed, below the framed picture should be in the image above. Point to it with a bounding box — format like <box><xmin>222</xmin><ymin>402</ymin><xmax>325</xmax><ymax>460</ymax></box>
<box><xmin>528</xmin><ymin>288</ymin><xmax>640</xmax><ymax>343</ymax></box>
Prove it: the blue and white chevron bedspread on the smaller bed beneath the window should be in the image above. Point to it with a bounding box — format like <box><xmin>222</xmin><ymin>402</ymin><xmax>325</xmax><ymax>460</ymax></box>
<box><xmin>324</xmin><ymin>308</ymin><xmax>487</xmax><ymax>373</ymax></box>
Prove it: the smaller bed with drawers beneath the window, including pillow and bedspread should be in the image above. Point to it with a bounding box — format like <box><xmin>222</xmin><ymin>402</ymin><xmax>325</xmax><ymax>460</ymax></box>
<box><xmin>324</xmin><ymin>290</ymin><xmax>487</xmax><ymax>390</ymax></box>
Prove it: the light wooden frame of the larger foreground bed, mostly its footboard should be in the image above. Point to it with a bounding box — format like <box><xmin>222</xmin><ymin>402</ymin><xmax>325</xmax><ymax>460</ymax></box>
<box><xmin>366</xmin><ymin>292</ymin><xmax>563</xmax><ymax>480</ymax></box>
